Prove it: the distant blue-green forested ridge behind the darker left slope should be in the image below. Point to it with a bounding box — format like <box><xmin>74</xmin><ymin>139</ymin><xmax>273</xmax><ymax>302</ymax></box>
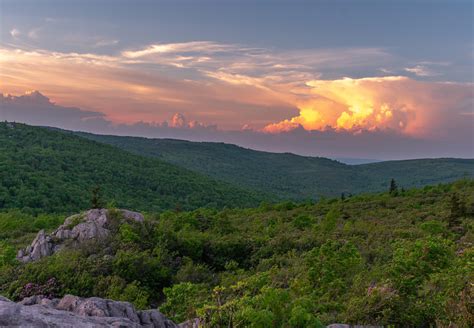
<box><xmin>79</xmin><ymin>133</ymin><xmax>474</xmax><ymax>200</ymax></box>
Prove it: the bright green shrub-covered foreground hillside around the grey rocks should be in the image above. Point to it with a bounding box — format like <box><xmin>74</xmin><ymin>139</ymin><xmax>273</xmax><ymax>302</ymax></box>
<box><xmin>0</xmin><ymin>180</ymin><xmax>474</xmax><ymax>327</ymax></box>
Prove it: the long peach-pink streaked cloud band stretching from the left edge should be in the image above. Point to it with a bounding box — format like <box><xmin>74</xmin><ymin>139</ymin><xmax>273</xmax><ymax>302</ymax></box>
<box><xmin>0</xmin><ymin>49</ymin><xmax>295</xmax><ymax>128</ymax></box>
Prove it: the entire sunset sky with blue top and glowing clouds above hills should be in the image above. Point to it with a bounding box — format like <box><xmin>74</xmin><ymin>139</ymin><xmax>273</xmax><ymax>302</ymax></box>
<box><xmin>0</xmin><ymin>0</ymin><xmax>474</xmax><ymax>159</ymax></box>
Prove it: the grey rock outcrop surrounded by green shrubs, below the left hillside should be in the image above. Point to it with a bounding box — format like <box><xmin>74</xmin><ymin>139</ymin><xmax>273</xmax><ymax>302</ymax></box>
<box><xmin>17</xmin><ymin>209</ymin><xmax>143</xmax><ymax>263</ymax></box>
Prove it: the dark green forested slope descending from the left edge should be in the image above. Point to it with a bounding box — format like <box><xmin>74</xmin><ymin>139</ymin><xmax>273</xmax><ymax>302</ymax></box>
<box><xmin>0</xmin><ymin>123</ymin><xmax>263</xmax><ymax>213</ymax></box>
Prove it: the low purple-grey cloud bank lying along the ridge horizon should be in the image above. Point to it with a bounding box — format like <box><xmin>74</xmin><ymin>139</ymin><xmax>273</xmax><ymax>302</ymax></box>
<box><xmin>0</xmin><ymin>91</ymin><xmax>474</xmax><ymax>159</ymax></box>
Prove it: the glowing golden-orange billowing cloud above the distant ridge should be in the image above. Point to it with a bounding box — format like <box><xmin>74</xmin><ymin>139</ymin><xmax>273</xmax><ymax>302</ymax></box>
<box><xmin>264</xmin><ymin>76</ymin><xmax>472</xmax><ymax>136</ymax></box>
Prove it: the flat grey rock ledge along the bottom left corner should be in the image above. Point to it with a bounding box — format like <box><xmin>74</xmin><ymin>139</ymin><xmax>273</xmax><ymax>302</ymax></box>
<box><xmin>0</xmin><ymin>295</ymin><xmax>184</xmax><ymax>328</ymax></box>
